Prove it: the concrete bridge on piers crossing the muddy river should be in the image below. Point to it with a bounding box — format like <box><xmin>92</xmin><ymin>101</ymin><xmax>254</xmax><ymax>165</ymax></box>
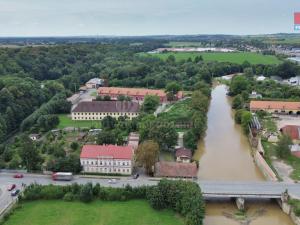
<box><xmin>198</xmin><ymin>181</ymin><xmax>300</xmax><ymax>211</ymax></box>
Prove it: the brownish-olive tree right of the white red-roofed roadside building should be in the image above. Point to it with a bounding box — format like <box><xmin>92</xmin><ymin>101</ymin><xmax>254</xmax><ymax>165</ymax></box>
<box><xmin>136</xmin><ymin>140</ymin><xmax>159</xmax><ymax>174</ymax></box>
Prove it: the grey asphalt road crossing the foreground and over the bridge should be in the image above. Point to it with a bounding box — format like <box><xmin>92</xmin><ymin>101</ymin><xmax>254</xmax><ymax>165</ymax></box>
<box><xmin>0</xmin><ymin>173</ymin><xmax>300</xmax><ymax>215</ymax></box>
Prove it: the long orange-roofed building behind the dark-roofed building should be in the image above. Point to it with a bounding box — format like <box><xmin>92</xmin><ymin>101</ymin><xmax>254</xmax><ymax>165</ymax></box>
<box><xmin>98</xmin><ymin>87</ymin><xmax>183</xmax><ymax>102</ymax></box>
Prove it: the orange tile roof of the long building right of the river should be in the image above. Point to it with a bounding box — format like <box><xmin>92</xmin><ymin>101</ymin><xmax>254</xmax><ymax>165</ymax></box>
<box><xmin>250</xmin><ymin>101</ymin><xmax>300</xmax><ymax>111</ymax></box>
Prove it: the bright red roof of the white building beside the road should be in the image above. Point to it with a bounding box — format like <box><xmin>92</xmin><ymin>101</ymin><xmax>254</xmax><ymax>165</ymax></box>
<box><xmin>80</xmin><ymin>145</ymin><xmax>133</xmax><ymax>160</ymax></box>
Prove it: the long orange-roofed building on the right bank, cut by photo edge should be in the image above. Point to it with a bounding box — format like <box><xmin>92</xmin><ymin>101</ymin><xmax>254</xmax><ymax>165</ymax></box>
<box><xmin>250</xmin><ymin>101</ymin><xmax>300</xmax><ymax>114</ymax></box>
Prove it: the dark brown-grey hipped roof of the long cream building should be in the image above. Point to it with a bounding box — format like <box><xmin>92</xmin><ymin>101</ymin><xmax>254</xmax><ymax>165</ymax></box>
<box><xmin>72</xmin><ymin>101</ymin><xmax>140</xmax><ymax>112</ymax></box>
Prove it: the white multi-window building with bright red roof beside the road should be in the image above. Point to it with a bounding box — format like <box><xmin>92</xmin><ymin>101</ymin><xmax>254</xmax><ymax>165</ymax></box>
<box><xmin>80</xmin><ymin>145</ymin><xmax>133</xmax><ymax>175</ymax></box>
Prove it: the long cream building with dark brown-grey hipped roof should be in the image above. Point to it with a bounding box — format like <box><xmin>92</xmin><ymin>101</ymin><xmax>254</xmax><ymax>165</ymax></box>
<box><xmin>71</xmin><ymin>101</ymin><xmax>140</xmax><ymax>120</ymax></box>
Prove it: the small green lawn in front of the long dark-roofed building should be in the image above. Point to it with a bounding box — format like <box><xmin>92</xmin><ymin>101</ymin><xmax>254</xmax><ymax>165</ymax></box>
<box><xmin>57</xmin><ymin>114</ymin><xmax>101</xmax><ymax>129</ymax></box>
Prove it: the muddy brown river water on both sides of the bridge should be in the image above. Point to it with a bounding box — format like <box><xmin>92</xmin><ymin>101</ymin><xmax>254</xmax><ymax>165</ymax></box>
<box><xmin>194</xmin><ymin>85</ymin><xmax>293</xmax><ymax>225</ymax></box>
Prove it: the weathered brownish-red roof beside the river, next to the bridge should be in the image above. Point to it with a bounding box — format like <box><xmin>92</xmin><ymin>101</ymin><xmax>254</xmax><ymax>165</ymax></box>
<box><xmin>155</xmin><ymin>162</ymin><xmax>198</xmax><ymax>178</ymax></box>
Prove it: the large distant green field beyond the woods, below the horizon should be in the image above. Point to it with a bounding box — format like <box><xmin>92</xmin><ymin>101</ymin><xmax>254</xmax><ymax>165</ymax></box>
<box><xmin>141</xmin><ymin>52</ymin><xmax>280</xmax><ymax>65</ymax></box>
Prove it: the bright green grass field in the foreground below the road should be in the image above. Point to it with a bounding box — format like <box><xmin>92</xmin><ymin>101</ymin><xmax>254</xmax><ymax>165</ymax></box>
<box><xmin>4</xmin><ymin>200</ymin><xmax>184</xmax><ymax>225</ymax></box>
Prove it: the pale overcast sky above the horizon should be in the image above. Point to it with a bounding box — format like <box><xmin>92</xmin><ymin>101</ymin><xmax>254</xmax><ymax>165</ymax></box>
<box><xmin>0</xmin><ymin>0</ymin><xmax>300</xmax><ymax>36</ymax></box>
